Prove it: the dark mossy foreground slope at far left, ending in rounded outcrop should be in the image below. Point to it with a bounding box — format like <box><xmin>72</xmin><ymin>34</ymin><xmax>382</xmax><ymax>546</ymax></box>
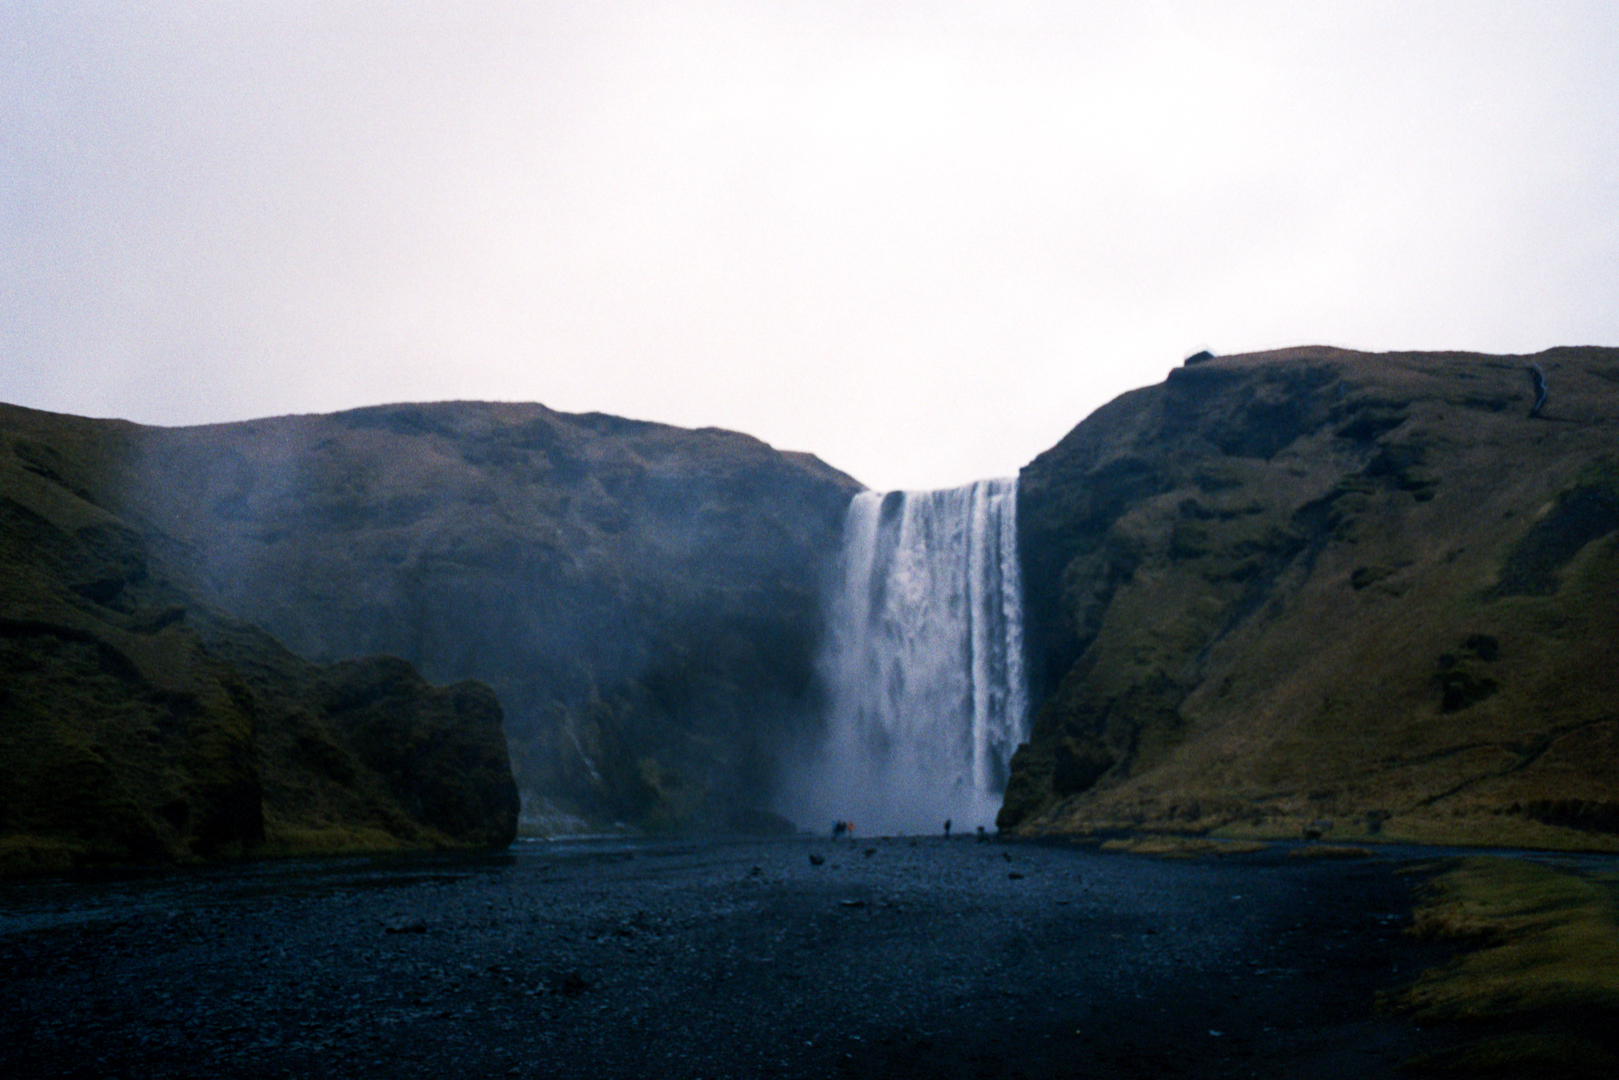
<box><xmin>0</xmin><ymin>408</ymin><xmax>518</xmax><ymax>873</ymax></box>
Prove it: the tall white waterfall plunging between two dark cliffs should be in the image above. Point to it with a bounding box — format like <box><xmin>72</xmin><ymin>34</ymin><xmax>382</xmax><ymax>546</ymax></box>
<box><xmin>779</xmin><ymin>479</ymin><xmax>1028</xmax><ymax>836</ymax></box>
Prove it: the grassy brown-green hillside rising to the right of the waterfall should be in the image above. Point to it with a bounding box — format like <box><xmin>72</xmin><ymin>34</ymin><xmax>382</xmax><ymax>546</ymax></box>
<box><xmin>1001</xmin><ymin>348</ymin><xmax>1619</xmax><ymax>847</ymax></box>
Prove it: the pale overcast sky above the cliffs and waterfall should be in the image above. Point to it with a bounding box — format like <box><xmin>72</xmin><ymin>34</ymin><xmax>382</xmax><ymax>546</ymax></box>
<box><xmin>0</xmin><ymin>0</ymin><xmax>1619</xmax><ymax>487</ymax></box>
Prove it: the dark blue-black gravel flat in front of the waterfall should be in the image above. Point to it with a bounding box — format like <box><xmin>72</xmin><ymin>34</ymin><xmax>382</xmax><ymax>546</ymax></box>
<box><xmin>0</xmin><ymin>837</ymin><xmax>1470</xmax><ymax>1080</ymax></box>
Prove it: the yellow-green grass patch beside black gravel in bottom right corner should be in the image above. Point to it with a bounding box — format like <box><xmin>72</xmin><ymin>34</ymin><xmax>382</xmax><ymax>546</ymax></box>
<box><xmin>1384</xmin><ymin>858</ymin><xmax>1619</xmax><ymax>1077</ymax></box>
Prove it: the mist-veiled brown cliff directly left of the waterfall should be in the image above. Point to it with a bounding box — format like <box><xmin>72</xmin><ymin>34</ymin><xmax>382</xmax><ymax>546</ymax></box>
<box><xmin>22</xmin><ymin>403</ymin><xmax>858</xmax><ymax>829</ymax></box>
